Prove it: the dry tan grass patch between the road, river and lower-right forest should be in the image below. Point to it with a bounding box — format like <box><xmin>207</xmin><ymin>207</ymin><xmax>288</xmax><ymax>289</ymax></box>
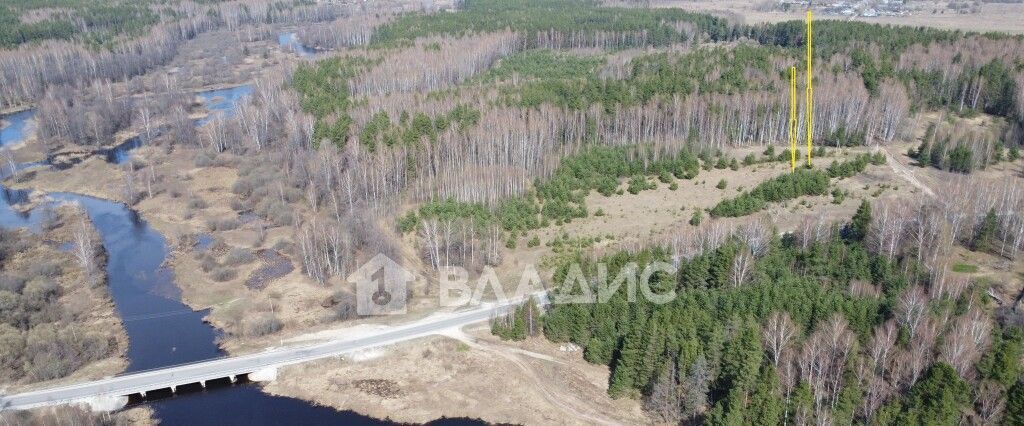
<box><xmin>265</xmin><ymin>328</ymin><xmax>648</xmax><ymax>424</ymax></box>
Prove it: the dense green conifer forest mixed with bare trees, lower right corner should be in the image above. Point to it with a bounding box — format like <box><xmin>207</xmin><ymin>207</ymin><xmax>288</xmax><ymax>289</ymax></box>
<box><xmin>528</xmin><ymin>202</ymin><xmax>1024</xmax><ymax>425</ymax></box>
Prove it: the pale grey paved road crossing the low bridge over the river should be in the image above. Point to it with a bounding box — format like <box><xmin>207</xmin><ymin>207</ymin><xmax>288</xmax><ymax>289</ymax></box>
<box><xmin>0</xmin><ymin>303</ymin><xmax>513</xmax><ymax>411</ymax></box>
